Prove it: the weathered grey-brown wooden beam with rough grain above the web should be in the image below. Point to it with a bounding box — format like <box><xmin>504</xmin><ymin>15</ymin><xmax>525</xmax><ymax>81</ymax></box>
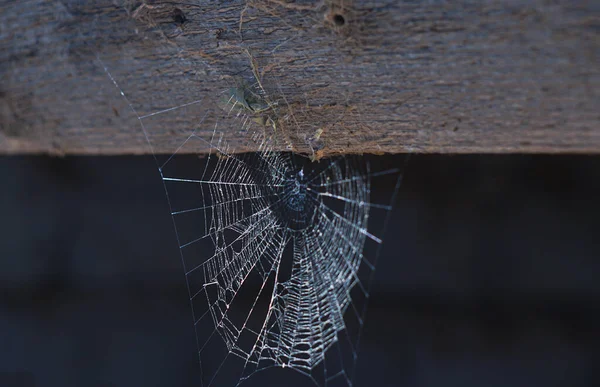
<box><xmin>0</xmin><ymin>0</ymin><xmax>600</xmax><ymax>156</ymax></box>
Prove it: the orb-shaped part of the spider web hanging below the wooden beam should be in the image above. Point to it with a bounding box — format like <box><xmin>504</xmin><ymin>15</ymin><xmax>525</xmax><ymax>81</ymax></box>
<box><xmin>161</xmin><ymin>140</ymin><xmax>398</xmax><ymax>386</ymax></box>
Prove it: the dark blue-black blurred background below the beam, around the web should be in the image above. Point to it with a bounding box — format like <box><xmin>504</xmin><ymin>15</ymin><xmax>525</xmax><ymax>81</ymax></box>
<box><xmin>0</xmin><ymin>155</ymin><xmax>600</xmax><ymax>387</ymax></box>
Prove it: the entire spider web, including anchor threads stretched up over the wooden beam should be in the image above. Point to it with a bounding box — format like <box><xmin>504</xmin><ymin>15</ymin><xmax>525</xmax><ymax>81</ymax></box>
<box><xmin>98</xmin><ymin>3</ymin><xmax>401</xmax><ymax>386</ymax></box>
